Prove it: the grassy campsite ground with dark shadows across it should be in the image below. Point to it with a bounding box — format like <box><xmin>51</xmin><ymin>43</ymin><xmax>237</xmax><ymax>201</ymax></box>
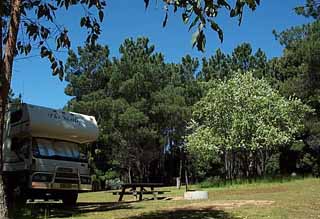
<box><xmin>16</xmin><ymin>178</ymin><xmax>320</xmax><ymax>219</ymax></box>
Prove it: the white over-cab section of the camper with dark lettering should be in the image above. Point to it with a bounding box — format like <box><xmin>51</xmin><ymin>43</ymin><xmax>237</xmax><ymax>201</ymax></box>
<box><xmin>10</xmin><ymin>104</ymin><xmax>98</xmax><ymax>144</ymax></box>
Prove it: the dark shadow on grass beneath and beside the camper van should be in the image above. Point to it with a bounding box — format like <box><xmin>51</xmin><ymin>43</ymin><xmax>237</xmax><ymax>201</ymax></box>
<box><xmin>13</xmin><ymin>202</ymin><xmax>137</xmax><ymax>219</ymax></box>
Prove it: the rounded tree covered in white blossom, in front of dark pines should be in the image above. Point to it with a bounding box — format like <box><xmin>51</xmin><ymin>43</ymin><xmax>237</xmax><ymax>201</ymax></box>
<box><xmin>186</xmin><ymin>73</ymin><xmax>311</xmax><ymax>179</ymax></box>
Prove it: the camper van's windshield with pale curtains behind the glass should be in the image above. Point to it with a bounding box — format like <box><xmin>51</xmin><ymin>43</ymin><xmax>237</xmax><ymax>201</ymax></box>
<box><xmin>33</xmin><ymin>138</ymin><xmax>80</xmax><ymax>161</ymax></box>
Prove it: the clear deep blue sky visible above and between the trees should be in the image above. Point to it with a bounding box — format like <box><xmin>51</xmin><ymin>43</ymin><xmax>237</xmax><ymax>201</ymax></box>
<box><xmin>12</xmin><ymin>0</ymin><xmax>310</xmax><ymax>108</ymax></box>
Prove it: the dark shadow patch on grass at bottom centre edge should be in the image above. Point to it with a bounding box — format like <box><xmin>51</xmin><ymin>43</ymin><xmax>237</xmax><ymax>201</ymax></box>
<box><xmin>127</xmin><ymin>208</ymin><xmax>236</xmax><ymax>219</ymax></box>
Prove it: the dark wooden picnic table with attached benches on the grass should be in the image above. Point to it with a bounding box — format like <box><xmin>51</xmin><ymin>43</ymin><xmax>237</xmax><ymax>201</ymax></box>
<box><xmin>113</xmin><ymin>183</ymin><xmax>169</xmax><ymax>202</ymax></box>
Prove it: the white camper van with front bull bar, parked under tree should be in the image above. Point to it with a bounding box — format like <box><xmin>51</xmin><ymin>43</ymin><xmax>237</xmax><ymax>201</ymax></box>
<box><xmin>3</xmin><ymin>103</ymin><xmax>98</xmax><ymax>205</ymax></box>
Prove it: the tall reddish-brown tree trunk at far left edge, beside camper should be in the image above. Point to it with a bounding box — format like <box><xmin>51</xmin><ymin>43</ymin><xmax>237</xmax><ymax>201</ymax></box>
<box><xmin>0</xmin><ymin>0</ymin><xmax>21</xmax><ymax>218</ymax></box>
